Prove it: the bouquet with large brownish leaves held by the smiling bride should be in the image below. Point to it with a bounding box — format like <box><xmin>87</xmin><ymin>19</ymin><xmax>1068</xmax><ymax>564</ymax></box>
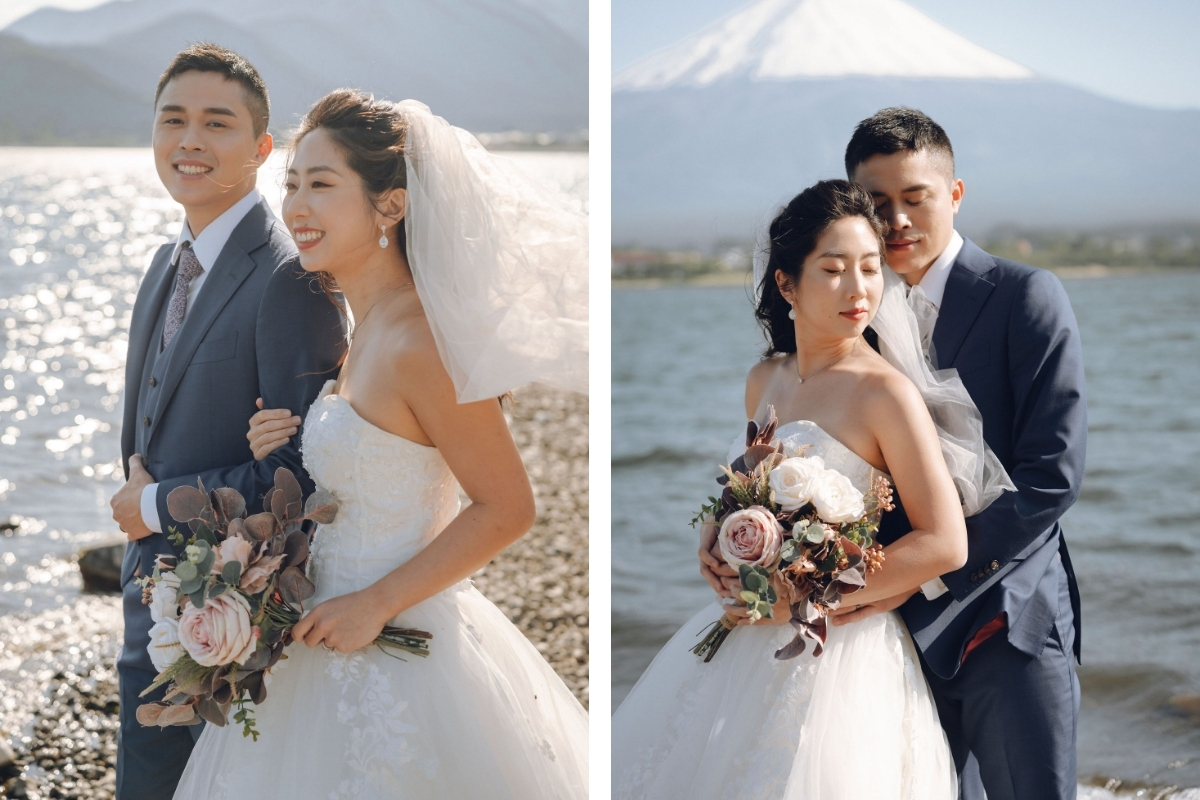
<box><xmin>137</xmin><ymin>467</ymin><xmax>433</xmax><ymax>740</ymax></box>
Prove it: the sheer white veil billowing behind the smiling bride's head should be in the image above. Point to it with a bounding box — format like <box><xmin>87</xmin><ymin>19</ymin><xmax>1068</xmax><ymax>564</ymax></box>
<box><xmin>396</xmin><ymin>100</ymin><xmax>588</xmax><ymax>403</ymax></box>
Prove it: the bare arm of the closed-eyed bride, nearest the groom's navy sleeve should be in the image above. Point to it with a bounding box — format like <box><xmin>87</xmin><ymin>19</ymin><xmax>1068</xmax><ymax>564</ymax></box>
<box><xmin>844</xmin><ymin>374</ymin><xmax>967</xmax><ymax>608</ymax></box>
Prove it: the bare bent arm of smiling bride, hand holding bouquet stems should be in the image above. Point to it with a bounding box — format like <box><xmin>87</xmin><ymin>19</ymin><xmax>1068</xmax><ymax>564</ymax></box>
<box><xmin>293</xmin><ymin>337</ymin><xmax>535</xmax><ymax>652</ymax></box>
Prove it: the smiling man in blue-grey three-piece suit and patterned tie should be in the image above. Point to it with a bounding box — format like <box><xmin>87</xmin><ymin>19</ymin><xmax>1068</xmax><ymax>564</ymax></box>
<box><xmin>112</xmin><ymin>43</ymin><xmax>346</xmax><ymax>800</ymax></box>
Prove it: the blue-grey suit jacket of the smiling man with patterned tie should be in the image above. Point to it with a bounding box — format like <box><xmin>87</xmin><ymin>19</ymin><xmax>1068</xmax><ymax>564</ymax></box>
<box><xmin>121</xmin><ymin>196</ymin><xmax>346</xmax><ymax>669</ymax></box>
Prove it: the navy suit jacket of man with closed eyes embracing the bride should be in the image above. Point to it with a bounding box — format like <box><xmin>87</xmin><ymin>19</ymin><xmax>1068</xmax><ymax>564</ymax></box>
<box><xmin>880</xmin><ymin>240</ymin><xmax>1087</xmax><ymax>679</ymax></box>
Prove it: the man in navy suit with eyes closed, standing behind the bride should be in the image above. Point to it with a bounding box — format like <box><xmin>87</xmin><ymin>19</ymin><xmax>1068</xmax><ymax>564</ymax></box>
<box><xmin>838</xmin><ymin>108</ymin><xmax>1087</xmax><ymax>800</ymax></box>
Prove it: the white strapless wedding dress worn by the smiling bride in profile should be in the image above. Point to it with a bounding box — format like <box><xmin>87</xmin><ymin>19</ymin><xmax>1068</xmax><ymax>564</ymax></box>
<box><xmin>175</xmin><ymin>381</ymin><xmax>588</xmax><ymax>800</ymax></box>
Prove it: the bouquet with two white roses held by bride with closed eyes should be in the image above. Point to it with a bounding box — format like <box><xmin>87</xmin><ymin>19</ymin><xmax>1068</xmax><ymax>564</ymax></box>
<box><xmin>692</xmin><ymin>407</ymin><xmax>893</xmax><ymax>662</ymax></box>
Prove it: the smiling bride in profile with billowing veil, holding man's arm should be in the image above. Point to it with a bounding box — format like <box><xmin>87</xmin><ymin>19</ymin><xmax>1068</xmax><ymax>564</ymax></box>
<box><xmin>175</xmin><ymin>90</ymin><xmax>588</xmax><ymax>800</ymax></box>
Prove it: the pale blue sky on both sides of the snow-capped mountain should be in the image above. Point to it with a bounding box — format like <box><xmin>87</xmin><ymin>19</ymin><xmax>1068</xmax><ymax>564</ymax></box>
<box><xmin>612</xmin><ymin>0</ymin><xmax>1200</xmax><ymax>108</ymax></box>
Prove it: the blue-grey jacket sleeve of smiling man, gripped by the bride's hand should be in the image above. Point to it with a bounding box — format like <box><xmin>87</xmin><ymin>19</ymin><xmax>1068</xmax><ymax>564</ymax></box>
<box><xmin>156</xmin><ymin>258</ymin><xmax>346</xmax><ymax>533</ymax></box>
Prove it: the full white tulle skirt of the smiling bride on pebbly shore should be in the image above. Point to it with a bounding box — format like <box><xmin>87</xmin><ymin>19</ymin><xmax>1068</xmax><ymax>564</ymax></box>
<box><xmin>175</xmin><ymin>582</ymin><xmax>588</xmax><ymax>800</ymax></box>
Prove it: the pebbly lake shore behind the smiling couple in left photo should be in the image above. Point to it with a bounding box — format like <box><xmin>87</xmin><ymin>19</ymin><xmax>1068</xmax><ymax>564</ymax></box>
<box><xmin>0</xmin><ymin>387</ymin><xmax>589</xmax><ymax>800</ymax></box>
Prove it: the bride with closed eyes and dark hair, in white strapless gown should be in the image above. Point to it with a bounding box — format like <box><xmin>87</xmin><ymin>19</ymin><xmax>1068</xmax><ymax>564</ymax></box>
<box><xmin>612</xmin><ymin>181</ymin><xmax>1007</xmax><ymax>800</ymax></box>
